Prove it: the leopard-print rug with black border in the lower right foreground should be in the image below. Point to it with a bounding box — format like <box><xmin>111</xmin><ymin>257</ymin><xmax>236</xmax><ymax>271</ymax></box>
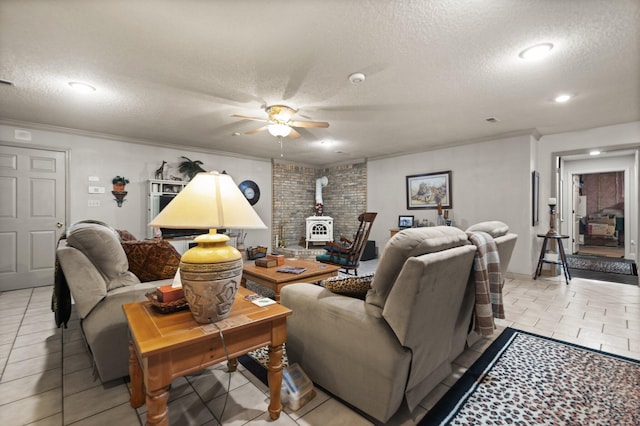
<box><xmin>422</xmin><ymin>328</ymin><xmax>640</xmax><ymax>425</ymax></box>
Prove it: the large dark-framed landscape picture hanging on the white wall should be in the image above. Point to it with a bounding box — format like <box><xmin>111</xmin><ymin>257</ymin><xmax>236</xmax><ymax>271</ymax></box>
<box><xmin>407</xmin><ymin>171</ymin><xmax>453</xmax><ymax>210</ymax></box>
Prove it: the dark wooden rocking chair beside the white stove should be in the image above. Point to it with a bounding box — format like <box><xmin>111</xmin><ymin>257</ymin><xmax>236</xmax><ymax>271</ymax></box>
<box><xmin>316</xmin><ymin>212</ymin><xmax>378</xmax><ymax>275</ymax></box>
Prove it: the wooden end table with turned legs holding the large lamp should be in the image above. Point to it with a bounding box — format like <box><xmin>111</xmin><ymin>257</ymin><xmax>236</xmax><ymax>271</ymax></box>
<box><xmin>123</xmin><ymin>288</ymin><xmax>291</xmax><ymax>425</ymax></box>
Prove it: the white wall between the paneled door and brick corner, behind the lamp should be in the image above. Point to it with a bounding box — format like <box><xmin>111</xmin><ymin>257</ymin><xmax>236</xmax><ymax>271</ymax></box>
<box><xmin>0</xmin><ymin>125</ymin><xmax>272</xmax><ymax>247</ymax></box>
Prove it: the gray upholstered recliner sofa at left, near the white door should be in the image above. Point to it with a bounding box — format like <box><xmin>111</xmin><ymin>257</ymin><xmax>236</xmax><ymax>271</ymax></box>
<box><xmin>56</xmin><ymin>223</ymin><xmax>179</xmax><ymax>382</ymax></box>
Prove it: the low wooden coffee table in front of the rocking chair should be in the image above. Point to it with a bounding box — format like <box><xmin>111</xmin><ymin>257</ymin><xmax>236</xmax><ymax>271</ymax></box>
<box><xmin>240</xmin><ymin>259</ymin><xmax>340</xmax><ymax>302</ymax></box>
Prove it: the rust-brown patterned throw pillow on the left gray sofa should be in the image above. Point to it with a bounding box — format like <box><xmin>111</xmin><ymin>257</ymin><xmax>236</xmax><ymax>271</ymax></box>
<box><xmin>122</xmin><ymin>239</ymin><xmax>180</xmax><ymax>282</ymax></box>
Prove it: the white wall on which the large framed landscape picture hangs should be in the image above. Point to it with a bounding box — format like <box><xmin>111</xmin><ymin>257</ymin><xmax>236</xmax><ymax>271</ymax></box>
<box><xmin>367</xmin><ymin>135</ymin><xmax>533</xmax><ymax>274</ymax></box>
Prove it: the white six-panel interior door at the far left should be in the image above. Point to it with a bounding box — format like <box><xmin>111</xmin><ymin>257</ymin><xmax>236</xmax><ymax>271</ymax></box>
<box><xmin>0</xmin><ymin>145</ymin><xmax>66</xmax><ymax>291</ymax></box>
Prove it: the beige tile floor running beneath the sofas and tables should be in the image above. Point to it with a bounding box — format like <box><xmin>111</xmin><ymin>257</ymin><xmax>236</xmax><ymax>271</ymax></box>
<box><xmin>0</xmin><ymin>261</ymin><xmax>640</xmax><ymax>426</ymax></box>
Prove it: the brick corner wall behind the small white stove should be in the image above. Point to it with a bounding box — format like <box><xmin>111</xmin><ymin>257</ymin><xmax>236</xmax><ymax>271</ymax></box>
<box><xmin>271</xmin><ymin>161</ymin><xmax>367</xmax><ymax>247</ymax></box>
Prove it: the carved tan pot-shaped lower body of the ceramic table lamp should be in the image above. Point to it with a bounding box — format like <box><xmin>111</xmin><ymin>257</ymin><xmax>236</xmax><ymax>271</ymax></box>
<box><xmin>180</xmin><ymin>259</ymin><xmax>242</xmax><ymax>324</ymax></box>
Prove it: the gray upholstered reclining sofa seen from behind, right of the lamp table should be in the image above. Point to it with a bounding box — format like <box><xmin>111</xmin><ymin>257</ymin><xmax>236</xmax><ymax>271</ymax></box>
<box><xmin>281</xmin><ymin>222</ymin><xmax>516</xmax><ymax>422</ymax></box>
